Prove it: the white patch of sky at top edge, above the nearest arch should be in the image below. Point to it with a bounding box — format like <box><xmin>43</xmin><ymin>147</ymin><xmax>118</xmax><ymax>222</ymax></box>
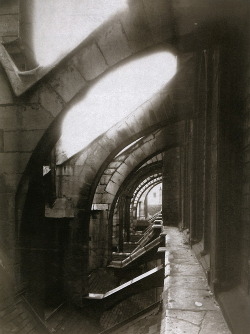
<box><xmin>31</xmin><ymin>0</ymin><xmax>127</xmax><ymax>66</ymax></box>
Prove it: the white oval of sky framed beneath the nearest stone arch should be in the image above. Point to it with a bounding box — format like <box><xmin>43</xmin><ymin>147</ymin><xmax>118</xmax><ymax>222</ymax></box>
<box><xmin>61</xmin><ymin>51</ymin><xmax>176</xmax><ymax>158</ymax></box>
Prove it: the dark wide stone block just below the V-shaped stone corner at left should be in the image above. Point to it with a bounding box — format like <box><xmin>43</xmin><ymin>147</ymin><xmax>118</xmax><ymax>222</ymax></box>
<box><xmin>20</xmin><ymin>105</ymin><xmax>54</xmax><ymax>130</ymax></box>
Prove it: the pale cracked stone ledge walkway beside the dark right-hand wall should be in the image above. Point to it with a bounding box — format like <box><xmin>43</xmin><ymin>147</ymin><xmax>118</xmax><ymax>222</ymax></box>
<box><xmin>160</xmin><ymin>227</ymin><xmax>231</xmax><ymax>334</ymax></box>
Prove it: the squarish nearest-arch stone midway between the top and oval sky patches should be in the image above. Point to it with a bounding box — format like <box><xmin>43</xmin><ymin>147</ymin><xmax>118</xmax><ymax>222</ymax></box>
<box><xmin>73</xmin><ymin>42</ymin><xmax>108</xmax><ymax>80</ymax></box>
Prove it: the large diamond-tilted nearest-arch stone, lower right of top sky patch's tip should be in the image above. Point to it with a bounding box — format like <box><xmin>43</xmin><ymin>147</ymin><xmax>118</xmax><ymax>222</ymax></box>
<box><xmin>49</xmin><ymin>63</ymin><xmax>86</xmax><ymax>102</ymax></box>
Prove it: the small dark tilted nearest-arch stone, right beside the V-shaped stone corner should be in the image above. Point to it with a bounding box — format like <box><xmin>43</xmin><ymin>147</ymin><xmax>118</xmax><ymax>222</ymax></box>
<box><xmin>37</xmin><ymin>85</ymin><xmax>64</xmax><ymax>117</ymax></box>
